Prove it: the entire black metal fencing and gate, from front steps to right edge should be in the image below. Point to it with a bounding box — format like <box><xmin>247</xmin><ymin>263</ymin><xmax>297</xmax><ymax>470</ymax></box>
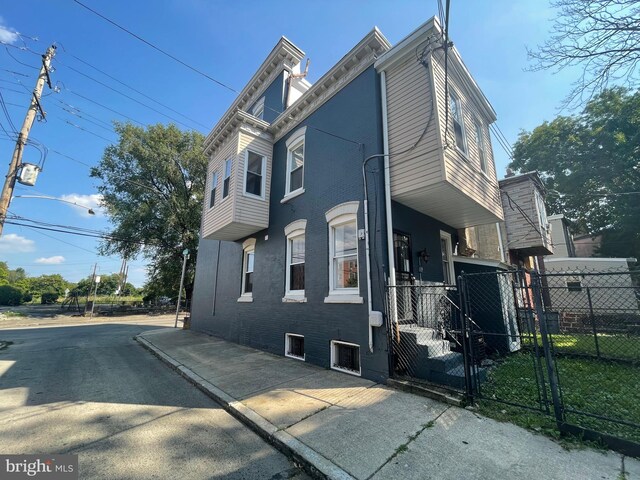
<box><xmin>388</xmin><ymin>270</ymin><xmax>640</xmax><ymax>456</ymax></box>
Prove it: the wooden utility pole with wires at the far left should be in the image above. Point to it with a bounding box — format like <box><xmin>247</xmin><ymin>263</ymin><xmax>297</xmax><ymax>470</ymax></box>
<box><xmin>0</xmin><ymin>45</ymin><xmax>56</xmax><ymax>236</ymax></box>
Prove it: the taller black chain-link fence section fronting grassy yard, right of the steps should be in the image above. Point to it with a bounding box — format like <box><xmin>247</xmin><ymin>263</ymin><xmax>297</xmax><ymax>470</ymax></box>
<box><xmin>460</xmin><ymin>270</ymin><xmax>640</xmax><ymax>455</ymax></box>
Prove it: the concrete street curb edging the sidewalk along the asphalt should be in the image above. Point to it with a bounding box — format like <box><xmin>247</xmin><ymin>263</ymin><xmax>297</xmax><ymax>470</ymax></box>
<box><xmin>133</xmin><ymin>335</ymin><xmax>355</xmax><ymax>480</ymax></box>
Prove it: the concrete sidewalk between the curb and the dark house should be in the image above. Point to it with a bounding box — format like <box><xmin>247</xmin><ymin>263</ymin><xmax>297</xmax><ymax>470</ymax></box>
<box><xmin>136</xmin><ymin>329</ymin><xmax>640</xmax><ymax>480</ymax></box>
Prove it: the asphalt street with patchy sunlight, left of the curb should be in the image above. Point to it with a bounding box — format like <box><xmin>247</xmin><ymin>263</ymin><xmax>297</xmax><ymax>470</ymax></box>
<box><xmin>0</xmin><ymin>320</ymin><xmax>307</xmax><ymax>479</ymax></box>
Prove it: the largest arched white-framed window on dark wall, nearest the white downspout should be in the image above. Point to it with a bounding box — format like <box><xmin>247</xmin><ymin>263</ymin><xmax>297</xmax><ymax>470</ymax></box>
<box><xmin>325</xmin><ymin>202</ymin><xmax>362</xmax><ymax>303</ymax></box>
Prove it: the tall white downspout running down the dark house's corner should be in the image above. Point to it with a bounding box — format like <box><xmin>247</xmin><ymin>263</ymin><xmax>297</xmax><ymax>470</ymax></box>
<box><xmin>380</xmin><ymin>70</ymin><xmax>398</xmax><ymax>324</ymax></box>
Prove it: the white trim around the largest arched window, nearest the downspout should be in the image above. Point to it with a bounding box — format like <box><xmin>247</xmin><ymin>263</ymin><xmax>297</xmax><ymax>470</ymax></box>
<box><xmin>324</xmin><ymin>202</ymin><xmax>363</xmax><ymax>303</ymax></box>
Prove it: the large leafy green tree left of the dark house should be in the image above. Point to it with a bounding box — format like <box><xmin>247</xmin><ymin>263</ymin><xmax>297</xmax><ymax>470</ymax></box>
<box><xmin>91</xmin><ymin>123</ymin><xmax>207</xmax><ymax>298</ymax></box>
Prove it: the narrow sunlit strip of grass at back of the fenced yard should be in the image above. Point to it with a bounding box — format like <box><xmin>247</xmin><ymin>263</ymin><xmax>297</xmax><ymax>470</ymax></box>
<box><xmin>522</xmin><ymin>333</ymin><xmax>640</xmax><ymax>361</ymax></box>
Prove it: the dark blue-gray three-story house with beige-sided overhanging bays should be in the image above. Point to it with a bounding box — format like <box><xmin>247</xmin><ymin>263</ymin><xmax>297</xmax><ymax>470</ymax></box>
<box><xmin>191</xmin><ymin>18</ymin><xmax>503</xmax><ymax>381</ymax></box>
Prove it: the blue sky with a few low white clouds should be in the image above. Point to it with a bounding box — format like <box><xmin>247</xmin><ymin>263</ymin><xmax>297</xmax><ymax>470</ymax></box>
<box><xmin>0</xmin><ymin>0</ymin><xmax>575</xmax><ymax>287</ymax></box>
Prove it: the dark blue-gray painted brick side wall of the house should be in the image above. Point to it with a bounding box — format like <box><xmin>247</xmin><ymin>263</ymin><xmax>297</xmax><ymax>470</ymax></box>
<box><xmin>192</xmin><ymin>67</ymin><xmax>389</xmax><ymax>381</ymax></box>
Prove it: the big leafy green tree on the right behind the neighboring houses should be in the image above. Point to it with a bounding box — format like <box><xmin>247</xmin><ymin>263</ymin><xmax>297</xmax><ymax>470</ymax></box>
<box><xmin>510</xmin><ymin>88</ymin><xmax>640</xmax><ymax>258</ymax></box>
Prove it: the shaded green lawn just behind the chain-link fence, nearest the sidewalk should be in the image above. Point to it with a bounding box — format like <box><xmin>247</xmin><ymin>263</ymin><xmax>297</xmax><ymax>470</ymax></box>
<box><xmin>479</xmin><ymin>352</ymin><xmax>640</xmax><ymax>443</ymax></box>
